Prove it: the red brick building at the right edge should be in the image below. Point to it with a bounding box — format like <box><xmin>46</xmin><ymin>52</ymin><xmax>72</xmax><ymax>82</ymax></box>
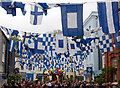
<box><xmin>105</xmin><ymin>42</ymin><xmax>120</xmax><ymax>82</ymax></box>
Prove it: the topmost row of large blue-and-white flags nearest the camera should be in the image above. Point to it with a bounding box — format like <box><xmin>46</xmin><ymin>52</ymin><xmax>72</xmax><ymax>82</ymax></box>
<box><xmin>0</xmin><ymin>1</ymin><xmax>119</xmax><ymax>36</ymax></box>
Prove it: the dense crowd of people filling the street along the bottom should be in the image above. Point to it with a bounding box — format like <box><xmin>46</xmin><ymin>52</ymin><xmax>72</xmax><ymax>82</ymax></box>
<box><xmin>2</xmin><ymin>80</ymin><xmax>120</xmax><ymax>88</ymax></box>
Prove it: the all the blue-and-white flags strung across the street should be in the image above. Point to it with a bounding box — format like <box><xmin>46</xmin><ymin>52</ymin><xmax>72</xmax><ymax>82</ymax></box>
<box><xmin>0</xmin><ymin>2</ymin><xmax>120</xmax><ymax>72</ymax></box>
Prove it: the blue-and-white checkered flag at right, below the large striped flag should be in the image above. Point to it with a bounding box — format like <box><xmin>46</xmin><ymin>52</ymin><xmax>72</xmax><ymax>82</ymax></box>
<box><xmin>99</xmin><ymin>34</ymin><xmax>113</xmax><ymax>53</ymax></box>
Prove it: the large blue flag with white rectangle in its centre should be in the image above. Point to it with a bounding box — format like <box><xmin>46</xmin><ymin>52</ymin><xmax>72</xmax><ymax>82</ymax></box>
<box><xmin>61</xmin><ymin>4</ymin><xmax>84</xmax><ymax>36</ymax></box>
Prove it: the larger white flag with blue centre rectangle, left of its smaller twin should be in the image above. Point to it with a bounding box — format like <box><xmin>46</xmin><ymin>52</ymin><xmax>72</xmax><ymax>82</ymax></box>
<box><xmin>55</xmin><ymin>34</ymin><xmax>67</xmax><ymax>53</ymax></box>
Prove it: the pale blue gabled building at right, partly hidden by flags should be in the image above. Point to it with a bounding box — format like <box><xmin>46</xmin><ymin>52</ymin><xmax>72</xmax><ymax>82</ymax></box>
<box><xmin>84</xmin><ymin>11</ymin><xmax>105</xmax><ymax>81</ymax></box>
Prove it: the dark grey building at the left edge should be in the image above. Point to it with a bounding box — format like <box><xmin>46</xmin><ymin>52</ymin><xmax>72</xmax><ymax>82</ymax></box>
<box><xmin>0</xmin><ymin>29</ymin><xmax>15</xmax><ymax>87</ymax></box>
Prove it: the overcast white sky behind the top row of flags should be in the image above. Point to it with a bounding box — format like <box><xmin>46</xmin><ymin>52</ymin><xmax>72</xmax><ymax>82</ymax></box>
<box><xmin>0</xmin><ymin>0</ymin><xmax>102</xmax><ymax>33</ymax></box>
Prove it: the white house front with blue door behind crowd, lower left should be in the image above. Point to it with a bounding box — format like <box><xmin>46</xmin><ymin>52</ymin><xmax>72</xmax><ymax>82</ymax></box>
<box><xmin>15</xmin><ymin>56</ymin><xmax>43</xmax><ymax>81</ymax></box>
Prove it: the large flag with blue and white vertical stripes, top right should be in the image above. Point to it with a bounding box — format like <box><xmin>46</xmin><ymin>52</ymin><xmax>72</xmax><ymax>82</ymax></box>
<box><xmin>98</xmin><ymin>1</ymin><xmax>119</xmax><ymax>33</ymax></box>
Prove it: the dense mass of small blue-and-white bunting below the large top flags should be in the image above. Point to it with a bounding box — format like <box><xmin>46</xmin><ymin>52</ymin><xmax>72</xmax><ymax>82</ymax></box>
<box><xmin>1</xmin><ymin>23</ymin><xmax>119</xmax><ymax>71</ymax></box>
